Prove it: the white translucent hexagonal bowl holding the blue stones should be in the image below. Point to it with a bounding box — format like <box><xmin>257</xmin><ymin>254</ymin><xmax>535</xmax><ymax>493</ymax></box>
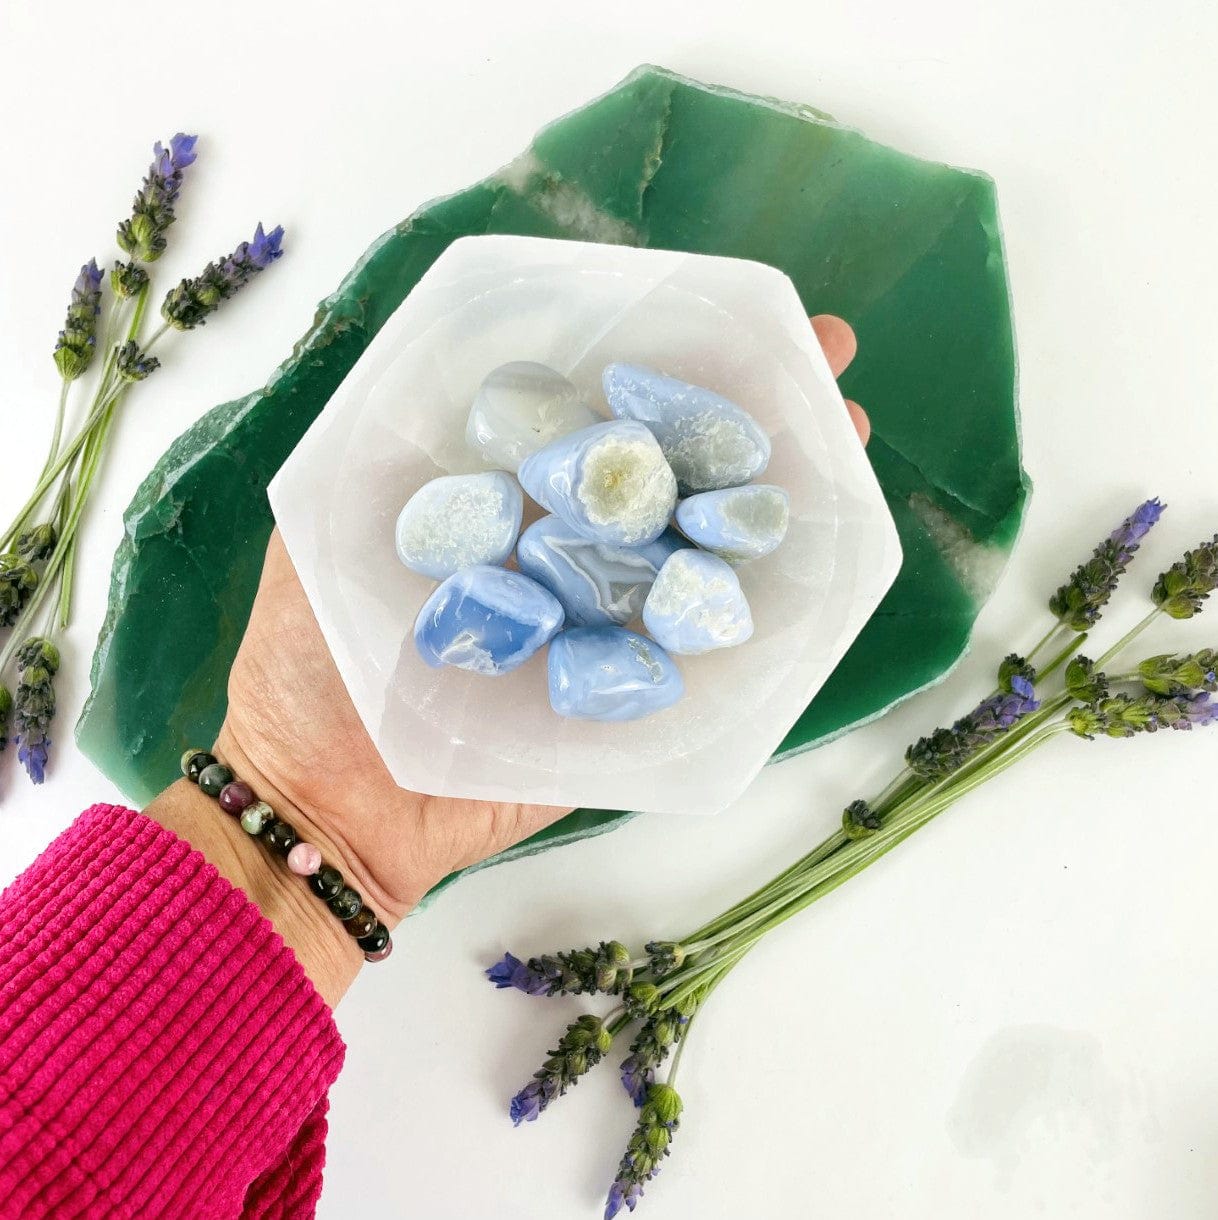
<box><xmin>270</xmin><ymin>237</ymin><xmax>901</xmax><ymax>813</ymax></box>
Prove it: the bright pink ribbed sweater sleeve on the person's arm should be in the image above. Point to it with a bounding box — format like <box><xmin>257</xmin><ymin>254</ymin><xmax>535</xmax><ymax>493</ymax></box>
<box><xmin>0</xmin><ymin>805</ymin><xmax>344</xmax><ymax>1220</ymax></box>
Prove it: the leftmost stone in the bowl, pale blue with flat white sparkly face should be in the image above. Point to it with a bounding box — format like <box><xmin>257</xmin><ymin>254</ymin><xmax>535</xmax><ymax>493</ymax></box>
<box><xmin>394</xmin><ymin>470</ymin><xmax>525</xmax><ymax>581</ymax></box>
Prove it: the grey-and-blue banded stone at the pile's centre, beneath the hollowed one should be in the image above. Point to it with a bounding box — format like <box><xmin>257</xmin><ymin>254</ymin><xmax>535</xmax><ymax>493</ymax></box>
<box><xmin>516</xmin><ymin>516</ymin><xmax>690</xmax><ymax>627</ymax></box>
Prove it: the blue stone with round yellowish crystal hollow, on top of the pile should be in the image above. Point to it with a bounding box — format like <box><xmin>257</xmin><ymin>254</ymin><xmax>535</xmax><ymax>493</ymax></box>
<box><xmin>520</xmin><ymin>420</ymin><xmax>676</xmax><ymax>547</ymax></box>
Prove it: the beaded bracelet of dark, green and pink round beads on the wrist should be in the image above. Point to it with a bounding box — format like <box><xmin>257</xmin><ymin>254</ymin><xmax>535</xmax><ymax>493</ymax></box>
<box><xmin>182</xmin><ymin>749</ymin><xmax>393</xmax><ymax>961</ymax></box>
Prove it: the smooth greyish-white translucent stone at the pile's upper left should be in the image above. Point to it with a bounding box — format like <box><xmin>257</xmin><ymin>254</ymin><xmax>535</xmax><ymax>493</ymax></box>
<box><xmin>465</xmin><ymin>360</ymin><xmax>600</xmax><ymax>472</ymax></box>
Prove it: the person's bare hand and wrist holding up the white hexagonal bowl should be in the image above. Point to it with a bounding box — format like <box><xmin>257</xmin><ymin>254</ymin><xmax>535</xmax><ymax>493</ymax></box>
<box><xmin>149</xmin><ymin>315</ymin><xmax>870</xmax><ymax>1003</ymax></box>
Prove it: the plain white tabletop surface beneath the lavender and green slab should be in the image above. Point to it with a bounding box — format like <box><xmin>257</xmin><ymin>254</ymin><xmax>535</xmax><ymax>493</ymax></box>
<box><xmin>0</xmin><ymin>0</ymin><xmax>1218</xmax><ymax>1220</ymax></box>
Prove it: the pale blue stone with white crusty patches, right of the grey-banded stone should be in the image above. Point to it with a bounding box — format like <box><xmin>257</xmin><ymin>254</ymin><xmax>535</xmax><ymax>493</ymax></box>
<box><xmin>643</xmin><ymin>548</ymin><xmax>753</xmax><ymax>654</ymax></box>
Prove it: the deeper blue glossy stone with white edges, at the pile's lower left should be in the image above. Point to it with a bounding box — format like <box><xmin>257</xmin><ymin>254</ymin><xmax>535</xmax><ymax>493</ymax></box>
<box><xmin>415</xmin><ymin>565</ymin><xmax>563</xmax><ymax>675</ymax></box>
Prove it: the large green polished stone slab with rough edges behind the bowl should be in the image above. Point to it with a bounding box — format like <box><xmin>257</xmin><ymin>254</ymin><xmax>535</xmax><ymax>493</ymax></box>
<box><xmin>77</xmin><ymin>67</ymin><xmax>1029</xmax><ymax>888</ymax></box>
